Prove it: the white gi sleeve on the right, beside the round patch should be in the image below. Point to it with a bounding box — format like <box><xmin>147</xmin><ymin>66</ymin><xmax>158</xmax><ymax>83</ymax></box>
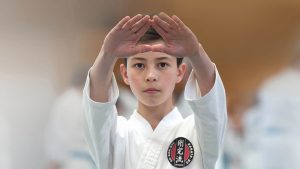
<box><xmin>184</xmin><ymin>65</ymin><xmax>227</xmax><ymax>169</ymax></box>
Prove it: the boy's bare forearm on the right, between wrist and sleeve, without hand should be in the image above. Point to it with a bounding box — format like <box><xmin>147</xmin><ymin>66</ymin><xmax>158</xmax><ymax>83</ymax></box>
<box><xmin>189</xmin><ymin>44</ymin><xmax>215</xmax><ymax>96</ymax></box>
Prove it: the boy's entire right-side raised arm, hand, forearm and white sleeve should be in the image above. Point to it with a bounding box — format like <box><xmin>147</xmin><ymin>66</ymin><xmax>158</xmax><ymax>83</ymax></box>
<box><xmin>152</xmin><ymin>13</ymin><xmax>227</xmax><ymax>169</ymax></box>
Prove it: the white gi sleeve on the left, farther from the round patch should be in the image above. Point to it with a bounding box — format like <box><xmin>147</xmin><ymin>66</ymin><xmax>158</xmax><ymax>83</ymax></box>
<box><xmin>83</xmin><ymin>69</ymin><xmax>119</xmax><ymax>169</ymax></box>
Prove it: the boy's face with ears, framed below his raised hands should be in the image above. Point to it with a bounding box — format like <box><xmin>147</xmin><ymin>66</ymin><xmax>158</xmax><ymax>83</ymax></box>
<box><xmin>120</xmin><ymin>42</ymin><xmax>185</xmax><ymax>107</ymax></box>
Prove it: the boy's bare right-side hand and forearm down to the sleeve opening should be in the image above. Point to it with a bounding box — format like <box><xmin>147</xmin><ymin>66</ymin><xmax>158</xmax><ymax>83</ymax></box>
<box><xmin>152</xmin><ymin>13</ymin><xmax>215</xmax><ymax>95</ymax></box>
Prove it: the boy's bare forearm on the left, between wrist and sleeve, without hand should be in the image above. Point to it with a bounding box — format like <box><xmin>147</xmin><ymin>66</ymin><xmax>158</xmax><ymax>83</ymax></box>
<box><xmin>90</xmin><ymin>50</ymin><xmax>117</xmax><ymax>102</ymax></box>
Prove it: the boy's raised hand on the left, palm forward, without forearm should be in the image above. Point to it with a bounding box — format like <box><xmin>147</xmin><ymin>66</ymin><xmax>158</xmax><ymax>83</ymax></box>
<box><xmin>102</xmin><ymin>14</ymin><xmax>151</xmax><ymax>57</ymax></box>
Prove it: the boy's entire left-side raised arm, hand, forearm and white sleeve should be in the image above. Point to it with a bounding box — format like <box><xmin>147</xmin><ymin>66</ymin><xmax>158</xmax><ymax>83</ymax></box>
<box><xmin>83</xmin><ymin>15</ymin><xmax>149</xmax><ymax>169</ymax></box>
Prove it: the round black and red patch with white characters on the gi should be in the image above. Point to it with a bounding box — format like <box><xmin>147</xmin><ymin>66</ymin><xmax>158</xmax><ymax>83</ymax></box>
<box><xmin>167</xmin><ymin>137</ymin><xmax>194</xmax><ymax>168</ymax></box>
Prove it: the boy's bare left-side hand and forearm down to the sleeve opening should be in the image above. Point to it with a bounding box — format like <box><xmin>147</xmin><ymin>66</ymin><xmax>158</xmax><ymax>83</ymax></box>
<box><xmin>90</xmin><ymin>14</ymin><xmax>151</xmax><ymax>102</ymax></box>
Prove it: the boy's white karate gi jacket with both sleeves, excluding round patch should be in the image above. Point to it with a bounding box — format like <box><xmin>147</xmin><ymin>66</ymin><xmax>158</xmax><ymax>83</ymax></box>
<box><xmin>83</xmin><ymin>67</ymin><xmax>227</xmax><ymax>169</ymax></box>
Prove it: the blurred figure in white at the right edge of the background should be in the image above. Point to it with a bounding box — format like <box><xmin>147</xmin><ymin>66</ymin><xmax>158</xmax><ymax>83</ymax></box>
<box><xmin>243</xmin><ymin>54</ymin><xmax>300</xmax><ymax>169</ymax></box>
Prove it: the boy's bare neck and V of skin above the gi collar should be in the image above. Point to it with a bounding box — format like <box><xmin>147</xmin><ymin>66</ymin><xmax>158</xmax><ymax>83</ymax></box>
<box><xmin>137</xmin><ymin>97</ymin><xmax>174</xmax><ymax>130</ymax></box>
